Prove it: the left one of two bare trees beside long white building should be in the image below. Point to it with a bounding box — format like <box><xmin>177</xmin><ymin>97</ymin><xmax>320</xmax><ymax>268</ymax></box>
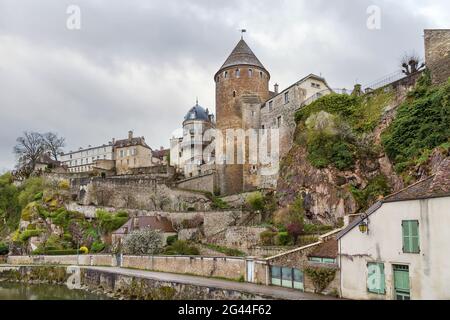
<box><xmin>14</xmin><ymin>131</ymin><xmax>45</xmax><ymax>175</ymax></box>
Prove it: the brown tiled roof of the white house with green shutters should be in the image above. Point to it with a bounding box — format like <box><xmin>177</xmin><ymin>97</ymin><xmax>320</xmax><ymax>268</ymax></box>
<box><xmin>337</xmin><ymin>158</ymin><xmax>450</xmax><ymax>239</ymax></box>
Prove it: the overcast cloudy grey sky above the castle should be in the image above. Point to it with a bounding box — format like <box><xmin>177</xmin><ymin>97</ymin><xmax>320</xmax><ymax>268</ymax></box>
<box><xmin>0</xmin><ymin>0</ymin><xmax>450</xmax><ymax>171</ymax></box>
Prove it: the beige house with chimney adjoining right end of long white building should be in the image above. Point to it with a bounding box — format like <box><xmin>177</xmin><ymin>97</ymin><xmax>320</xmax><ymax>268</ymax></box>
<box><xmin>114</xmin><ymin>131</ymin><xmax>157</xmax><ymax>175</ymax></box>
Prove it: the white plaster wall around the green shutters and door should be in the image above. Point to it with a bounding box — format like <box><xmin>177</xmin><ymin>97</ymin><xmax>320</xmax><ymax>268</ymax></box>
<box><xmin>339</xmin><ymin>197</ymin><xmax>450</xmax><ymax>300</ymax></box>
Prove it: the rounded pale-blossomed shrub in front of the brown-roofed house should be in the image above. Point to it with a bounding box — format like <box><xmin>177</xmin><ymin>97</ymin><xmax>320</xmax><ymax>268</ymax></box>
<box><xmin>123</xmin><ymin>228</ymin><xmax>163</xmax><ymax>255</ymax></box>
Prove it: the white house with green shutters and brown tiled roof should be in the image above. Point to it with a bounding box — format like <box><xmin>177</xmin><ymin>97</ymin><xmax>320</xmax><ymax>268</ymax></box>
<box><xmin>338</xmin><ymin>159</ymin><xmax>450</xmax><ymax>300</ymax></box>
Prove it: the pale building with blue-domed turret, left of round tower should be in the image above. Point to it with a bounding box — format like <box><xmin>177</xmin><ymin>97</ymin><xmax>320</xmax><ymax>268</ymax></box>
<box><xmin>170</xmin><ymin>101</ymin><xmax>215</xmax><ymax>177</ymax></box>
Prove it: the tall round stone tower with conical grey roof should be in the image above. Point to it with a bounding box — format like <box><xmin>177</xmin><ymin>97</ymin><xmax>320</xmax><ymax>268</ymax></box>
<box><xmin>214</xmin><ymin>39</ymin><xmax>270</xmax><ymax>195</ymax></box>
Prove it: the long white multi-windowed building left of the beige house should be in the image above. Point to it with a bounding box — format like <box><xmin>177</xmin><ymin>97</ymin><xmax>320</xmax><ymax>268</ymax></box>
<box><xmin>61</xmin><ymin>142</ymin><xmax>114</xmax><ymax>173</ymax></box>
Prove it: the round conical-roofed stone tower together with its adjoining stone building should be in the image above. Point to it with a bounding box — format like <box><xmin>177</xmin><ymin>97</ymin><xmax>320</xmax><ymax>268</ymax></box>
<box><xmin>214</xmin><ymin>39</ymin><xmax>332</xmax><ymax>195</ymax></box>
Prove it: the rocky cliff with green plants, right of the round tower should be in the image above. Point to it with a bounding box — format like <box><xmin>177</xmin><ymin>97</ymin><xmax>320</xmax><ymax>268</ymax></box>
<box><xmin>277</xmin><ymin>72</ymin><xmax>450</xmax><ymax>223</ymax></box>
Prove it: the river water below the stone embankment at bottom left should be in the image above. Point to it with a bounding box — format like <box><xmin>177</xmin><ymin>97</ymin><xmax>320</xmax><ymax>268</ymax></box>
<box><xmin>0</xmin><ymin>282</ymin><xmax>109</xmax><ymax>300</ymax></box>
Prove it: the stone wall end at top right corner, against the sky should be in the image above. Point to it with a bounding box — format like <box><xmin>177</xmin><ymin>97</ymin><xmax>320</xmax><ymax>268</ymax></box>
<box><xmin>425</xmin><ymin>29</ymin><xmax>450</xmax><ymax>84</ymax></box>
